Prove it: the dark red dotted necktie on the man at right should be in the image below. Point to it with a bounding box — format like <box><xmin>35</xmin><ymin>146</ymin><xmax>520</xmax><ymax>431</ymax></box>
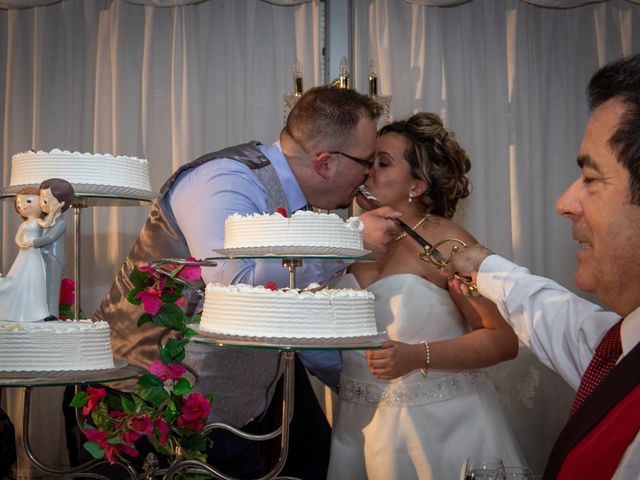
<box><xmin>569</xmin><ymin>319</ymin><xmax>622</xmax><ymax>416</ymax></box>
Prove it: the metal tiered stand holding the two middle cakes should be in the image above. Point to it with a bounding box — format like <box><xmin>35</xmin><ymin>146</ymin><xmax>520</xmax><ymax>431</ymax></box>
<box><xmin>155</xmin><ymin>254</ymin><xmax>386</xmax><ymax>480</ymax></box>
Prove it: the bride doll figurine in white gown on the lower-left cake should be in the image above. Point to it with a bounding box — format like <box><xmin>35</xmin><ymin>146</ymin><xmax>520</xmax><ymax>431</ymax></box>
<box><xmin>0</xmin><ymin>188</ymin><xmax>49</xmax><ymax>322</ymax></box>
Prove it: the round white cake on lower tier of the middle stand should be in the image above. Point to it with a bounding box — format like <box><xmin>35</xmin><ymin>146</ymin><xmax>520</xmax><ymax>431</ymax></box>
<box><xmin>200</xmin><ymin>283</ymin><xmax>378</xmax><ymax>338</ymax></box>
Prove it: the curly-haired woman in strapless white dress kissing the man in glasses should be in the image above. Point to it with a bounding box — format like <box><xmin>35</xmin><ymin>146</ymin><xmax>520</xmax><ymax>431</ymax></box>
<box><xmin>327</xmin><ymin>113</ymin><xmax>524</xmax><ymax>480</ymax></box>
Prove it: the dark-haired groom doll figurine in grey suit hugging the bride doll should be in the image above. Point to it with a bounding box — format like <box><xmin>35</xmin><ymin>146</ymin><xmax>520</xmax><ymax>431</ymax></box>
<box><xmin>27</xmin><ymin>178</ymin><xmax>75</xmax><ymax>320</ymax></box>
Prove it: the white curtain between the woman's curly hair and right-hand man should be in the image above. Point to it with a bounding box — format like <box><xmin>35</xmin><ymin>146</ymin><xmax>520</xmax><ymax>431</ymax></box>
<box><xmin>353</xmin><ymin>0</ymin><xmax>640</xmax><ymax>473</ymax></box>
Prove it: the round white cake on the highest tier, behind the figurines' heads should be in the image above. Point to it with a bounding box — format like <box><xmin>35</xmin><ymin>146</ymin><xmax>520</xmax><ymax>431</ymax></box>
<box><xmin>9</xmin><ymin>149</ymin><xmax>151</xmax><ymax>193</ymax></box>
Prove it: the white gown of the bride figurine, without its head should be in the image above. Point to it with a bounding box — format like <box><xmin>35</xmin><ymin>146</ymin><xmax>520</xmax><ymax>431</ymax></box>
<box><xmin>0</xmin><ymin>220</ymin><xmax>49</xmax><ymax>322</ymax></box>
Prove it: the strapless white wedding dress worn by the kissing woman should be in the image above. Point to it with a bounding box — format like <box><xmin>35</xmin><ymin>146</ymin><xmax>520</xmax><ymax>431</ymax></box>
<box><xmin>327</xmin><ymin>274</ymin><xmax>525</xmax><ymax>480</ymax></box>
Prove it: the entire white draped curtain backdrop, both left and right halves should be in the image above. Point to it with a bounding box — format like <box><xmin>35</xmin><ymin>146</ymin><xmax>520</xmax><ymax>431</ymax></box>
<box><xmin>0</xmin><ymin>0</ymin><xmax>640</xmax><ymax>471</ymax></box>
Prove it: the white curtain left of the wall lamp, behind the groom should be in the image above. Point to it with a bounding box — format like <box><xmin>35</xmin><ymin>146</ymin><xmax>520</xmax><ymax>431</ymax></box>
<box><xmin>0</xmin><ymin>0</ymin><xmax>321</xmax><ymax>315</ymax></box>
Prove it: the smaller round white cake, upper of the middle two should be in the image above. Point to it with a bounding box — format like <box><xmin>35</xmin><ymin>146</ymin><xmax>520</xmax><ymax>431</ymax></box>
<box><xmin>224</xmin><ymin>210</ymin><xmax>364</xmax><ymax>253</ymax></box>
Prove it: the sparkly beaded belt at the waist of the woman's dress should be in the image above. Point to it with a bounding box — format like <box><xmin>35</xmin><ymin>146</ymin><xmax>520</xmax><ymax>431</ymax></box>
<box><xmin>339</xmin><ymin>372</ymin><xmax>482</xmax><ymax>407</ymax></box>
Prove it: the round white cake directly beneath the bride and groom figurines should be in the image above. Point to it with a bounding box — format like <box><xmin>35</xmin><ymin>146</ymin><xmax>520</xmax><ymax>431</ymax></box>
<box><xmin>0</xmin><ymin>320</ymin><xmax>114</xmax><ymax>372</ymax></box>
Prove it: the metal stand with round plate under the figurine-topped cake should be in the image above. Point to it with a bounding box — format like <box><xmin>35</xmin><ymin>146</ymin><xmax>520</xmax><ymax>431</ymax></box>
<box><xmin>0</xmin><ymin>362</ymin><xmax>143</xmax><ymax>480</ymax></box>
